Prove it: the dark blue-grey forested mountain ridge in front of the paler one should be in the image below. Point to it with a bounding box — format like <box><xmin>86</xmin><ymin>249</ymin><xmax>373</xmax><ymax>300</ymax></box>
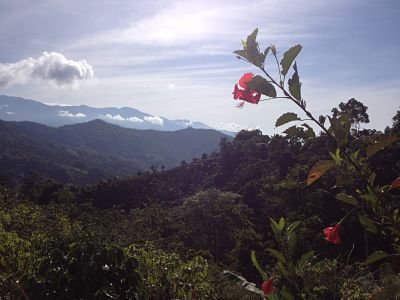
<box><xmin>0</xmin><ymin>120</ymin><xmax>229</xmax><ymax>184</ymax></box>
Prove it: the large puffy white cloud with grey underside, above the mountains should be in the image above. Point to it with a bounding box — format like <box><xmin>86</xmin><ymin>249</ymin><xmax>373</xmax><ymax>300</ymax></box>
<box><xmin>0</xmin><ymin>52</ymin><xmax>94</xmax><ymax>87</ymax></box>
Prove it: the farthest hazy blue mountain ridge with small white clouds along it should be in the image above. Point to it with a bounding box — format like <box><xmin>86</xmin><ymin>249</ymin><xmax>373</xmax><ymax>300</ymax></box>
<box><xmin>0</xmin><ymin>95</ymin><xmax>234</xmax><ymax>135</ymax></box>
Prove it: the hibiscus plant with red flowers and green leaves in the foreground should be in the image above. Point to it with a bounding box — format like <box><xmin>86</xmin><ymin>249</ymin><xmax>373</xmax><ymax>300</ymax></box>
<box><xmin>225</xmin><ymin>29</ymin><xmax>400</xmax><ymax>299</ymax></box>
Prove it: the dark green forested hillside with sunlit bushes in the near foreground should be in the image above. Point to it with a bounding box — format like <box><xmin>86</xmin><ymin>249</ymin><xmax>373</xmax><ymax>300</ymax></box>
<box><xmin>0</xmin><ymin>107</ymin><xmax>400</xmax><ymax>299</ymax></box>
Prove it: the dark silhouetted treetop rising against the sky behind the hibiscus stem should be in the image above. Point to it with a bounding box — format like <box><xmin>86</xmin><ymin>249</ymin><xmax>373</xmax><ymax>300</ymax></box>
<box><xmin>332</xmin><ymin>98</ymin><xmax>369</xmax><ymax>131</ymax></box>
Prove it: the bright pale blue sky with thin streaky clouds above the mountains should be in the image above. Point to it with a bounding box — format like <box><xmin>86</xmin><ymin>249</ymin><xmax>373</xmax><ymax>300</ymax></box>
<box><xmin>0</xmin><ymin>0</ymin><xmax>400</xmax><ymax>134</ymax></box>
